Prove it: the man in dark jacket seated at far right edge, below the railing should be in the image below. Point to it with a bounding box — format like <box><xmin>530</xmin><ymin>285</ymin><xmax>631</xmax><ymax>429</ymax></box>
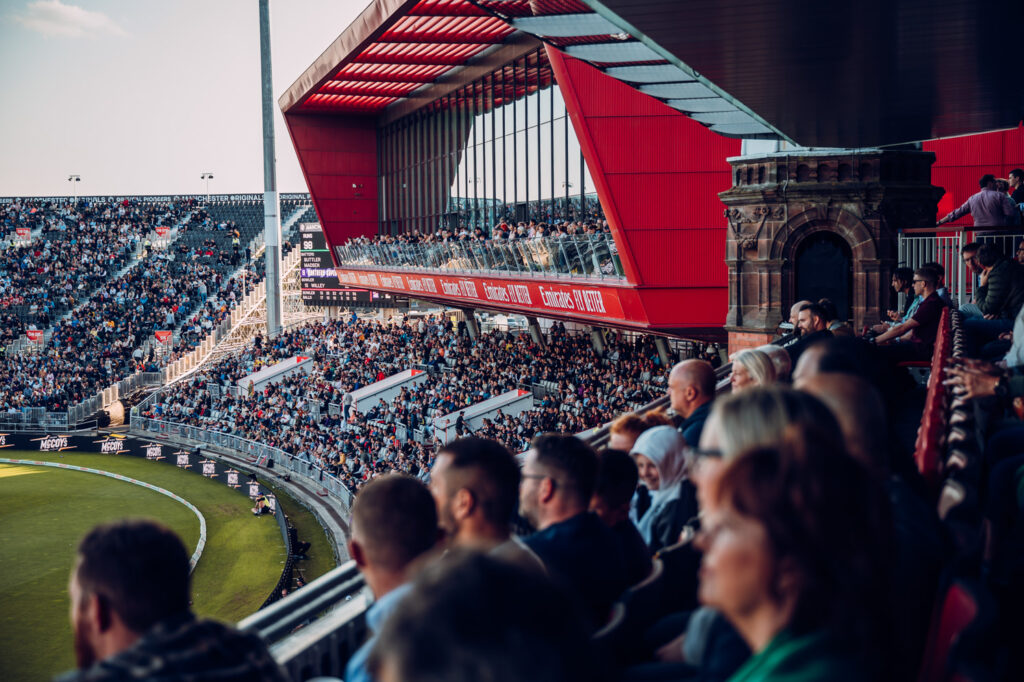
<box><xmin>964</xmin><ymin>244</ymin><xmax>1024</xmax><ymax>357</ymax></box>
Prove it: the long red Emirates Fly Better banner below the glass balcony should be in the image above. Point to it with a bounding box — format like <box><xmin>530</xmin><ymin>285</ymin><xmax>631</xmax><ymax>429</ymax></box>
<box><xmin>337</xmin><ymin>267</ymin><xmax>626</xmax><ymax>319</ymax></box>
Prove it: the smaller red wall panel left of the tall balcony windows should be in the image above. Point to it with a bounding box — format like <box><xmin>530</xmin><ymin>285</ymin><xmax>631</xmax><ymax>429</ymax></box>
<box><xmin>285</xmin><ymin>113</ymin><xmax>378</xmax><ymax>251</ymax></box>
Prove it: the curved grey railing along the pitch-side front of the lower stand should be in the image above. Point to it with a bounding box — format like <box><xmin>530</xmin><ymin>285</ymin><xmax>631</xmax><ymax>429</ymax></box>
<box><xmin>129</xmin><ymin>415</ymin><xmax>352</xmax><ymax>509</ymax></box>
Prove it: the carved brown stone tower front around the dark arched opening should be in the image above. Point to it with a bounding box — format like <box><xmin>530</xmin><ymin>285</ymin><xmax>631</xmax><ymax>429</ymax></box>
<box><xmin>719</xmin><ymin>150</ymin><xmax>942</xmax><ymax>352</ymax></box>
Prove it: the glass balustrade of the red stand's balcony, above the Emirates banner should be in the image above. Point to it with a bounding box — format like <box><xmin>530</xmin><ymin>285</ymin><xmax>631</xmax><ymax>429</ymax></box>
<box><xmin>335</xmin><ymin>233</ymin><xmax>626</xmax><ymax>280</ymax></box>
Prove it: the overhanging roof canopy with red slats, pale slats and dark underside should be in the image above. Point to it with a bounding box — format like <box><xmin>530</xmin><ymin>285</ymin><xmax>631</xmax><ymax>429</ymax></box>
<box><xmin>280</xmin><ymin>0</ymin><xmax>1024</xmax><ymax>147</ymax></box>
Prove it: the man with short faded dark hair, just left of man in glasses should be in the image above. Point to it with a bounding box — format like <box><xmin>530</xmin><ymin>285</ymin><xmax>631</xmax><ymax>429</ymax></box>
<box><xmin>430</xmin><ymin>436</ymin><xmax>544</xmax><ymax>571</ymax></box>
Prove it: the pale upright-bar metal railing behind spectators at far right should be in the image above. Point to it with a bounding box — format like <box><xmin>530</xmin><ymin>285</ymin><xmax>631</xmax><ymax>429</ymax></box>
<box><xmin>898</xmin><ymin>227</ymin><xmax>1024</xmax><ymax>305</ymax></box>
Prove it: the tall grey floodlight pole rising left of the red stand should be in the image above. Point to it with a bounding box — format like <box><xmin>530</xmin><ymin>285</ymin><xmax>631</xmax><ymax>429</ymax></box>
<box><xmin>259</xmin><ymin>0</ymin><xmax>284</xmax><ymax>339</ymax></box>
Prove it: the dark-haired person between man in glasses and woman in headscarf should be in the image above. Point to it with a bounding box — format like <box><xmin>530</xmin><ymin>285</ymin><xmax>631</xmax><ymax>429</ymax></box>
<box><xmin>590</xmin><ymin>450</ymin><xmax>650</xmax><ymax>585</ymax></box>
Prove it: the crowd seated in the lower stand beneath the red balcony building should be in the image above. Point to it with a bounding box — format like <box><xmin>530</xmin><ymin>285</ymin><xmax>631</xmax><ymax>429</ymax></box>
<box><xmin>143</xmin><ymin>316</ymin><xmax>664</xmax><ymax>491</ymax></box>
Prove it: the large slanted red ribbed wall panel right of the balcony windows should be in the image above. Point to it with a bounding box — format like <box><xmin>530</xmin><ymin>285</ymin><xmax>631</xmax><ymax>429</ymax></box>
<box><xmin>548</xmin><ymin>48</ymin><xmax>740</xmax><ymax>328</ymax></box>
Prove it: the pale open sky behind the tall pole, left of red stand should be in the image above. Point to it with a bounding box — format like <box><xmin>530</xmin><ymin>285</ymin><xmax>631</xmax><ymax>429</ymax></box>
<box><xmin>0</xmin><ymin>0</ymin><xmax>369</xmax><ymax>197</ymax></box>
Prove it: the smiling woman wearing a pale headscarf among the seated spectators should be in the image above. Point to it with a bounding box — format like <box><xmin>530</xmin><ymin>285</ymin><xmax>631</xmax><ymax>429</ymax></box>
<box><xmin>630</xmin><ymin>426</ymin><xmax>697</xmax><ymax>554</ymax></box>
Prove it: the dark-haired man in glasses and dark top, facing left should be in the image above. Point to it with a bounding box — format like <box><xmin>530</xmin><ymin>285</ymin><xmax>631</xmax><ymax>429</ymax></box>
<box><xmin>519</xmin><ymin>433</ymin><xmax>629</xmax><ymax>629</ymax></box>
